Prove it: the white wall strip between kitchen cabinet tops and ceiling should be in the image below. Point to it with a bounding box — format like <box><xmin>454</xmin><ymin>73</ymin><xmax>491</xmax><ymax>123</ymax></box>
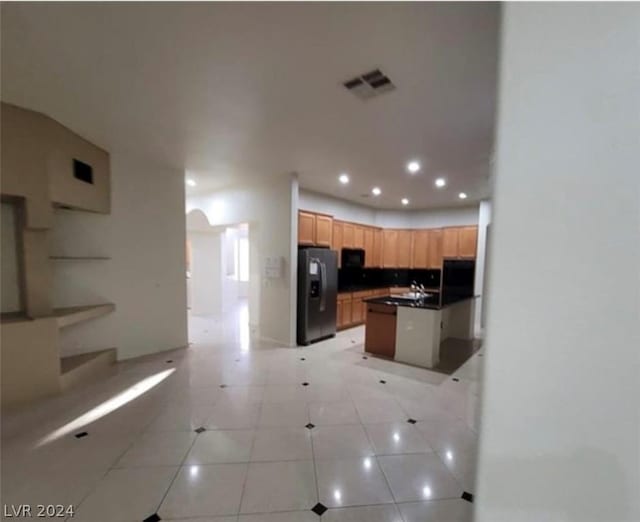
<box><xmin>299</xmin><ymin>189</ymin><xmax>478</xmax><ymax>228</ymax></box>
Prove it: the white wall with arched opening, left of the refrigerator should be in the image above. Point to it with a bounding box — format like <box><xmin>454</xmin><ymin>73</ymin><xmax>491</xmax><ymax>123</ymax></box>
<box><xmin>187</xmin><ymin>175</ymin><xmax>298</xmax><ymax>345</ymax></box>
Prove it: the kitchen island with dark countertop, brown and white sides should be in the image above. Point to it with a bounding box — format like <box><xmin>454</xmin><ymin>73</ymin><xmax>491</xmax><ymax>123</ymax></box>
<box><xmin>365</xmin><ymin>296</ymin><xmax>475</xmax><ymax>368</ymax></box>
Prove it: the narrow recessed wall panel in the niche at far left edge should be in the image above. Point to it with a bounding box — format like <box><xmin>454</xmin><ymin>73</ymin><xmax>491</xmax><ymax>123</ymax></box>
<box><xmin>0</xmin><ymin>203</ymin><xmax>22</xmax><ymax>314</ymax></box>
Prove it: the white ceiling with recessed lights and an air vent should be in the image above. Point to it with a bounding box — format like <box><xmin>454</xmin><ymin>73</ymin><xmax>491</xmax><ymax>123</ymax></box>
<box><xmin>2</xmin><ymin>2</ymin><xmax>499</xmax><ymax>208</ymax></box>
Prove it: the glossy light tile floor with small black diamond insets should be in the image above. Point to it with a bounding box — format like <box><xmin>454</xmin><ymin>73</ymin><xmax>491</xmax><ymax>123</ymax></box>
<box><xmin>2</xmin><ymin>302</ymin><xmax>482</xmax><ymax>522</ymax></box>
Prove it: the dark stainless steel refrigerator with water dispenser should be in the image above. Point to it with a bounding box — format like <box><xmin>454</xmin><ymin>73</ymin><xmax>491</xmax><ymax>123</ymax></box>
<box><xmin>297</xmin><ymin>248</ymin><xmax>338</xmax><ymax>346</ymax></box>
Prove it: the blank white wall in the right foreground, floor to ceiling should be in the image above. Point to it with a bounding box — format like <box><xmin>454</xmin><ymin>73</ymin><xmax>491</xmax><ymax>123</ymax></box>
<box><xmin>475</xmin><ymin>2</ymin><xmax>640</xmax><ymax>522</ymax></box>
